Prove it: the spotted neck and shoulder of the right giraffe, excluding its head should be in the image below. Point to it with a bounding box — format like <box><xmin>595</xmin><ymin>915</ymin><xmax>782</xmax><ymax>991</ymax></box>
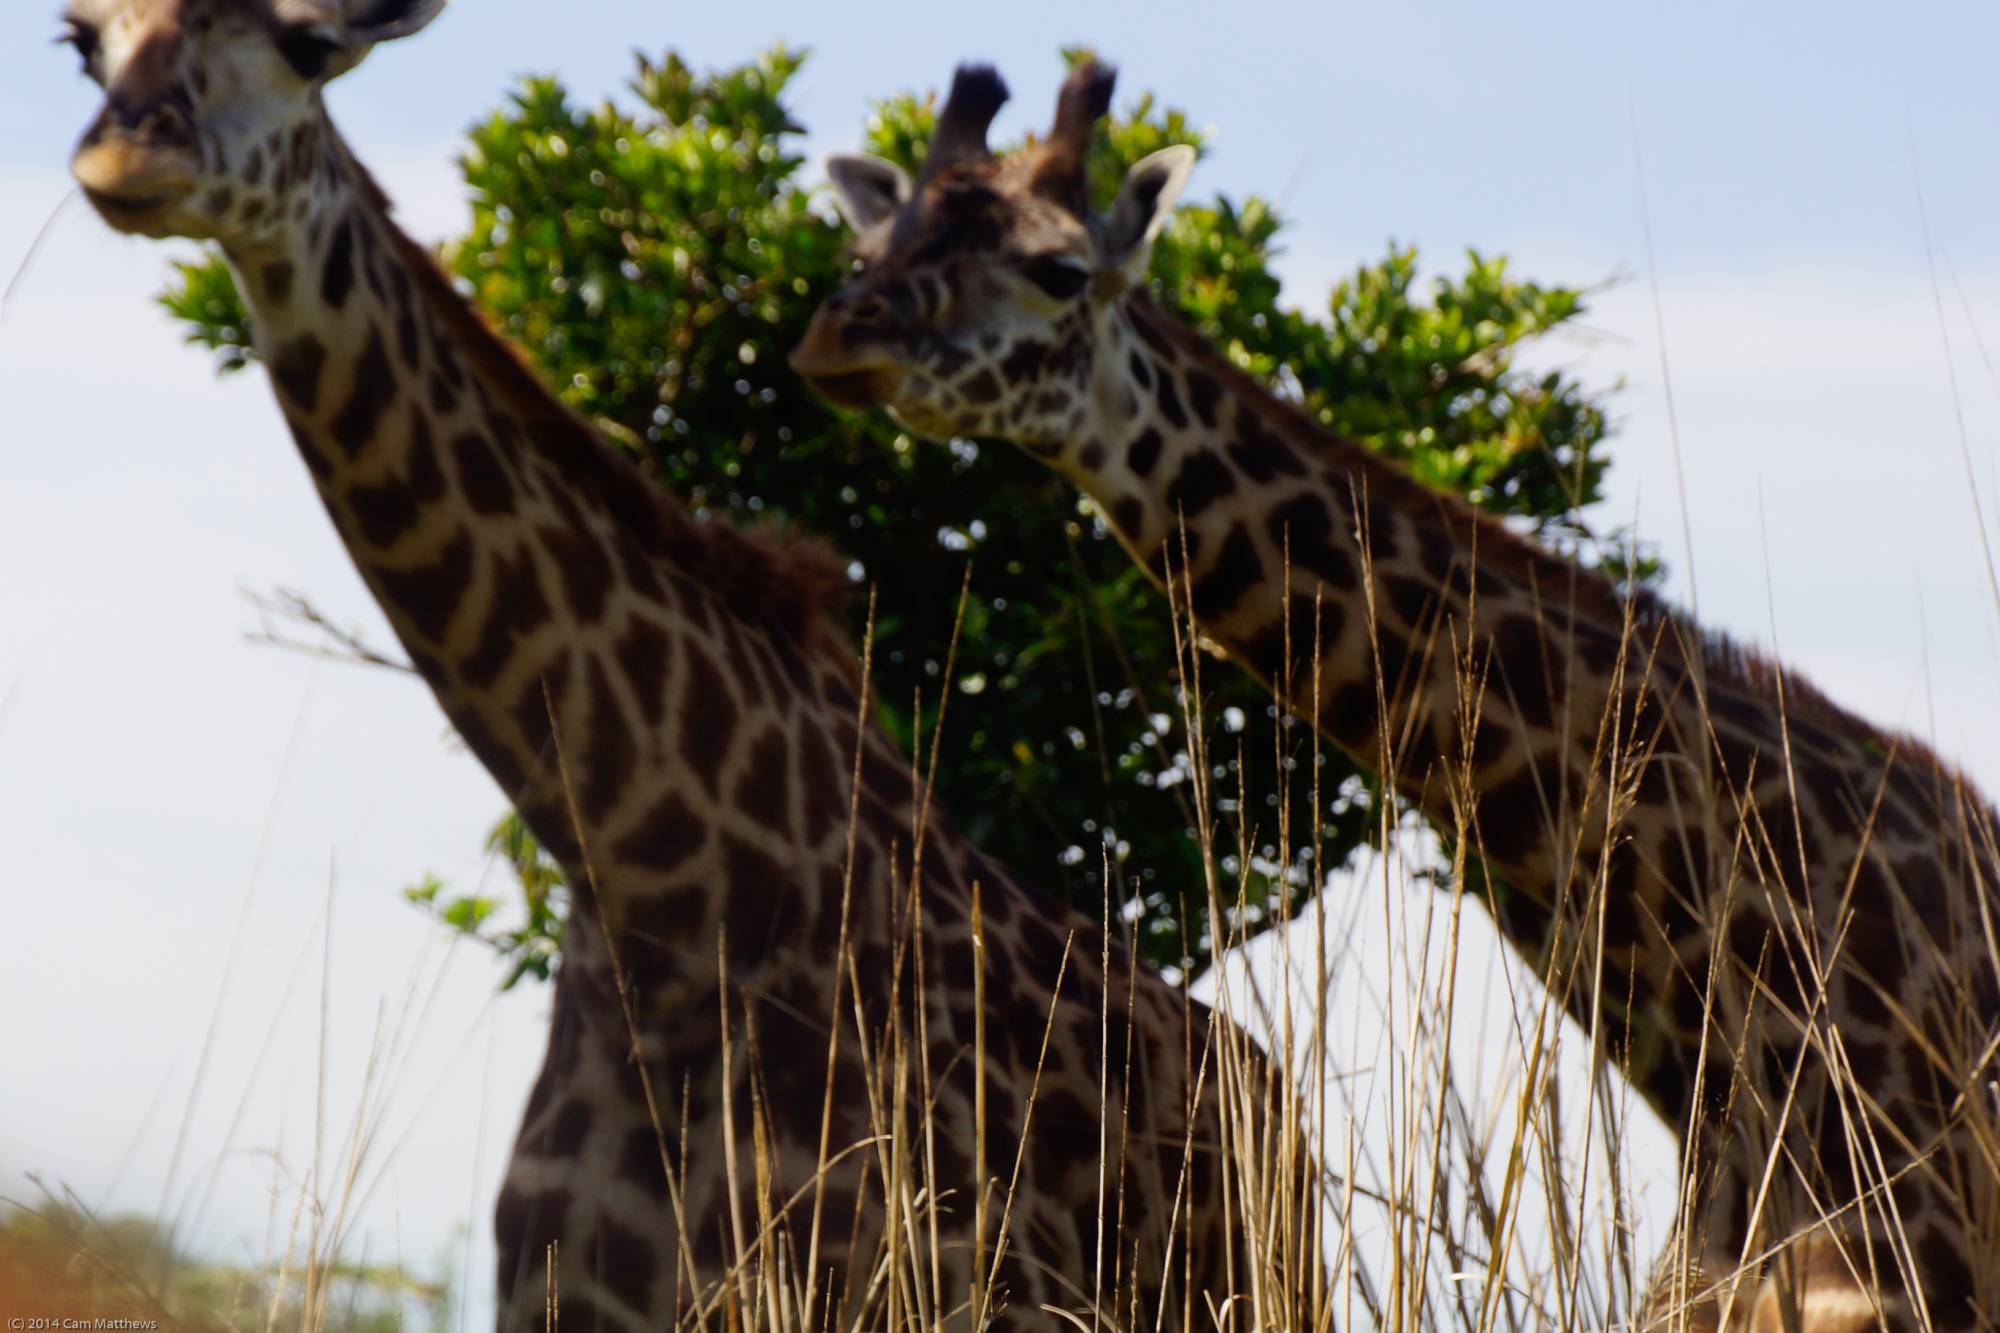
<box><xmin>1008</xmin><ymin>282</ymin><xmax>2000</xmax><ymax>1327</ymax></box>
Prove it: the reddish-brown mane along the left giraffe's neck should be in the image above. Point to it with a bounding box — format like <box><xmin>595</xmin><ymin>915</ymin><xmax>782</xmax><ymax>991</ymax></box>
<box><xmin>340</xmin><ymin>144</ymin><xmax>854</xmax><ymax>662</ymax></box>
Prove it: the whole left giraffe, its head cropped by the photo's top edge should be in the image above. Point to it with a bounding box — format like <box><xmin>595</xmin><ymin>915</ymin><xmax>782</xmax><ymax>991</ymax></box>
<box><xmin>68</xmin><ymin>15</ymin><xmax>1306</xmax><ymax>1329</ymax></box>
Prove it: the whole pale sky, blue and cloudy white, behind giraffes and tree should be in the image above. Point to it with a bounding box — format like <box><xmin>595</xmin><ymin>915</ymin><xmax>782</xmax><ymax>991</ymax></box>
<box><xmin>0</xmin><ymin>0</ymin><xmax>2000</xmax><ymax>1327</ymax></box>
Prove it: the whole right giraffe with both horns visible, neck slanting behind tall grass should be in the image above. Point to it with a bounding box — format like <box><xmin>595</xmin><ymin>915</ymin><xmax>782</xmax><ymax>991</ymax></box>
<box><xmin>792</xmin><ymin>62</ymin><xmax>2000</xmax><ymax>1333</ymax></box>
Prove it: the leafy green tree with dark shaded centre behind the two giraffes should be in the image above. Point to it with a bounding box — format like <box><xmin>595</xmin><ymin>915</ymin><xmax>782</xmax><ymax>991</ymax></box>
<box><xmin>164</xmin><ymin>48</ymin><xmax>1646</xmax><ymax>983</ymax></box>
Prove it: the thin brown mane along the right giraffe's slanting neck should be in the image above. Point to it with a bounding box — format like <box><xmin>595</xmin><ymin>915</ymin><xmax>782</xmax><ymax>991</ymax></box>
<box><xmin>1130</xmin><ymin>292</ymin><xmax>1992</xmax><ymax>792</ymax></box>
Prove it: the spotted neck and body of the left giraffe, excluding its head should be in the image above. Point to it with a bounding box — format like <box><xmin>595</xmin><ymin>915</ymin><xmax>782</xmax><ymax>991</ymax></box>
<box><xmin>215</xmin><ymin>130</ymin><xmax>1264</xmax><ymax>1329</ymax></box>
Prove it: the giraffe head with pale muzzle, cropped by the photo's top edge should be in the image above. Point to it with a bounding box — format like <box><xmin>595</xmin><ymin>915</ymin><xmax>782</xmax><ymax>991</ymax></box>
<box><xmin>64</xmin><ymin>0</ymin><xmax>444</xmax><ymax>248</ymax></box>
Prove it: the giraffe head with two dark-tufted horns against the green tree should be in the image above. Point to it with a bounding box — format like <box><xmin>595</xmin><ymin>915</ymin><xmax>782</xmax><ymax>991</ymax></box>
<box><xmin>792</xmin><ymin>62</ymin><xmax>1194</xmax><ymax>454</ymax></box>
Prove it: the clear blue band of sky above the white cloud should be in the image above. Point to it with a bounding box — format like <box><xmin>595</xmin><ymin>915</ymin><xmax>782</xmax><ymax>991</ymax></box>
<box><xmin>15</xmin><ymin>0</ymin><xmax>2000</xmax><ymax>256</ymax></box>
